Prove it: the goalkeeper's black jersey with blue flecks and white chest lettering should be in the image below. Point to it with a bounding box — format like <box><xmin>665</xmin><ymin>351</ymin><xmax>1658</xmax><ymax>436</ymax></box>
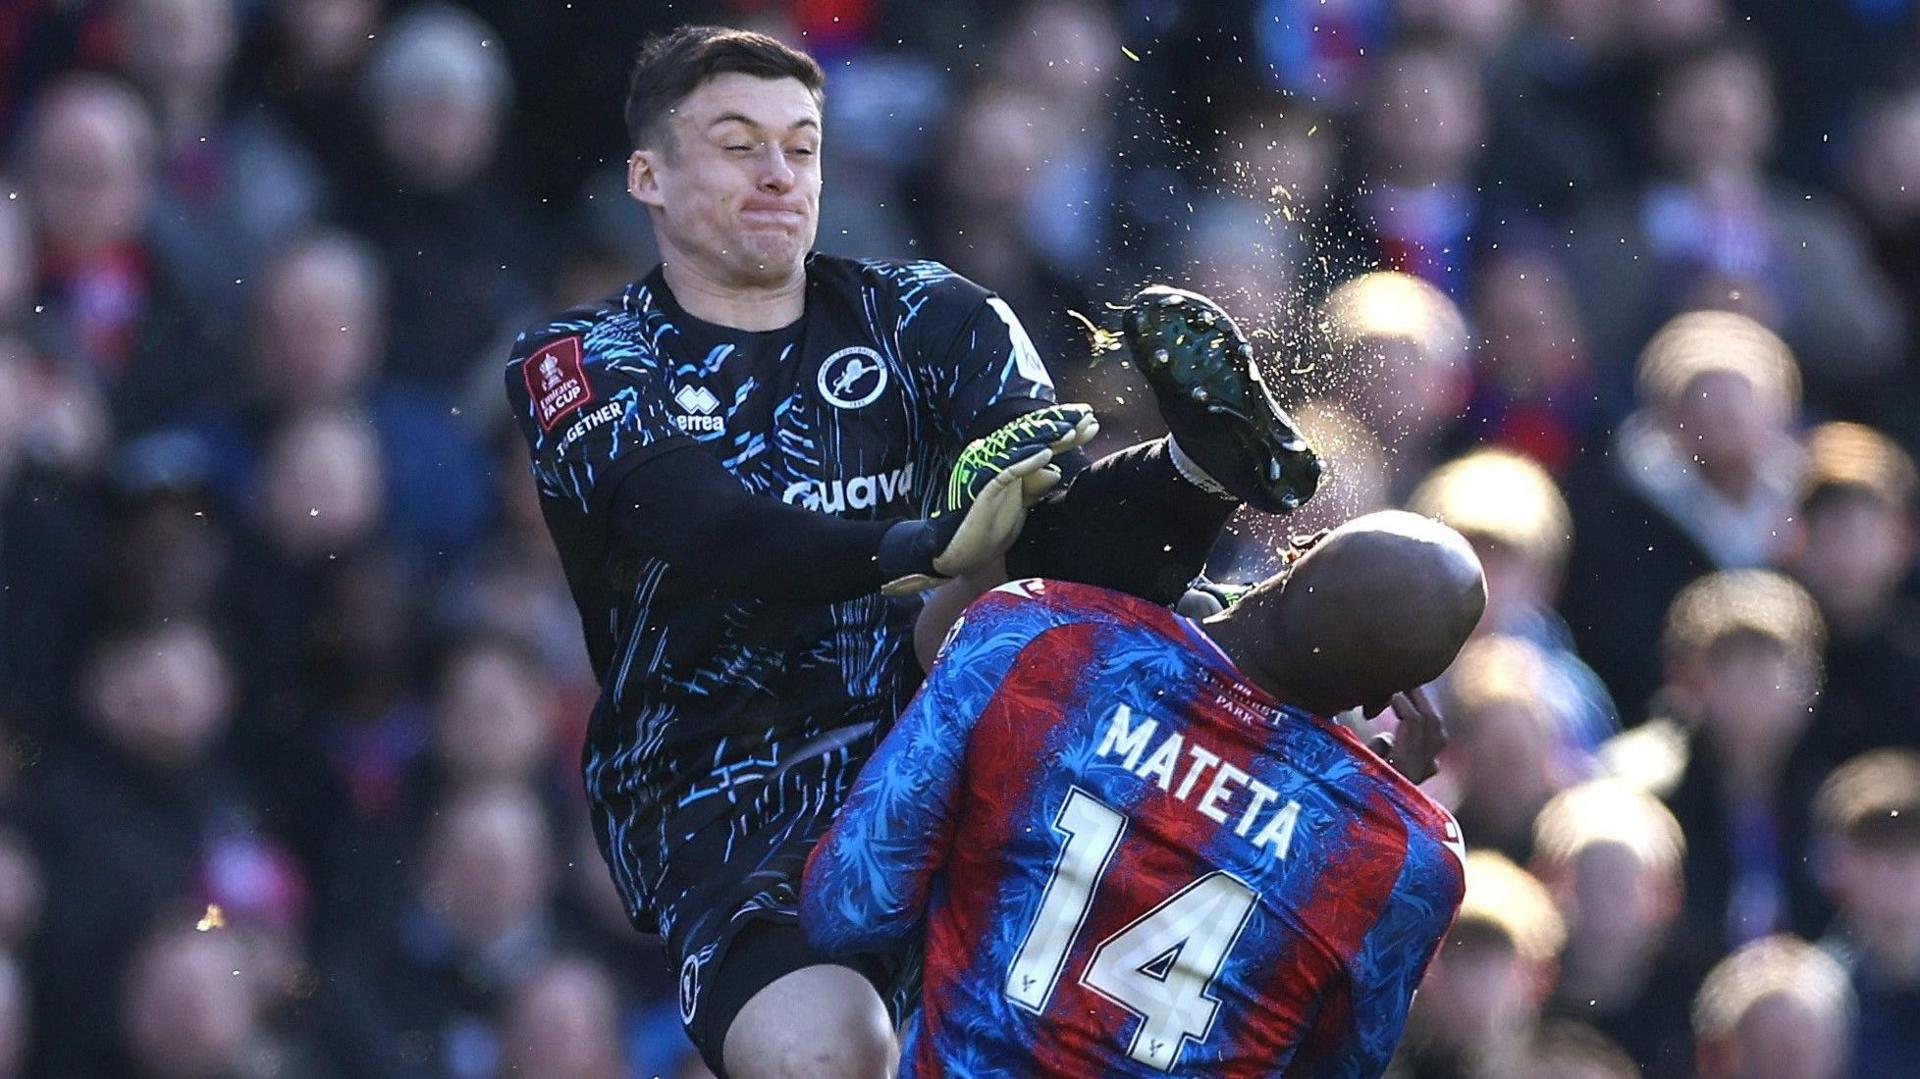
<box><xmin>507</xmin><ymin>255</ymin><xmax>1052</xmax><ymax>933</ymax></box>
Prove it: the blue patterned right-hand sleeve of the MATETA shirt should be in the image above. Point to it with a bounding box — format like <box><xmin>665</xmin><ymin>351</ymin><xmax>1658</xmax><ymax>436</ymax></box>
<box><xmin>1313</xmin><ymin>822</ymin><xmax>1465</xmax><ymax>1079</ymax></box>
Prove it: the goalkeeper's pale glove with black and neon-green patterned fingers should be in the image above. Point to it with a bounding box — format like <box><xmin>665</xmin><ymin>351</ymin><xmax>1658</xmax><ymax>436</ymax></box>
<box><xmin>879</xmin><ymin>405</ymin><xmax>1100</xmax><ymax>595</ymax></box>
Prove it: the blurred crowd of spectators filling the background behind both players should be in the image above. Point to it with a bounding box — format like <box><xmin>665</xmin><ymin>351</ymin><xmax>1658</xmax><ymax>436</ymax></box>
<box><xmin>0</xmin><ymin>0</ymin><xmax>1920</xmax><ymax>1079</ymax></box>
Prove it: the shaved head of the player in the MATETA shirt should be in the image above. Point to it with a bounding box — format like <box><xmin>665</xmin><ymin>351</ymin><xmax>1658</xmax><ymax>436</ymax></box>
<box><xmin>1213</xmin><ymin>511</ymin><xmax>1486</xmax><ymax>714</ymax></box>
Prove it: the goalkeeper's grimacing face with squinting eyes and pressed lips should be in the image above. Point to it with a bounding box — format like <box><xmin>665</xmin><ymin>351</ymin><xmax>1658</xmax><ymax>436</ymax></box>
<box><xmin>628</xmin><ymin>73</ymin><xmax>820</xmax><ymax>286</ymax></box>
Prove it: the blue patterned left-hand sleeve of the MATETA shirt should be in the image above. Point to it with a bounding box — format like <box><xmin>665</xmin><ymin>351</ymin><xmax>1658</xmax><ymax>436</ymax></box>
<box><xmin>801</xmin><ymin>586</ymin><xmax>1041</xmax><ymax>954</ymax></box>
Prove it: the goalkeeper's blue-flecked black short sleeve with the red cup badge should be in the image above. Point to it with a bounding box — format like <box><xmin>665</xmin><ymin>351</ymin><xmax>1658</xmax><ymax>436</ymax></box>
<box><xmin>507</xmin><ymin>319</ymin><xmax>695</xmax><ymax>513</ymax></box>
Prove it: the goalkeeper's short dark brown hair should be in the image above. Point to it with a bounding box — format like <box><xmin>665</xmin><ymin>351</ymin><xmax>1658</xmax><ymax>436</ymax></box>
<box><xmin>626</xmin><ymin>27</ymin><xmax>828</xmax><ymax>150</ymax></box>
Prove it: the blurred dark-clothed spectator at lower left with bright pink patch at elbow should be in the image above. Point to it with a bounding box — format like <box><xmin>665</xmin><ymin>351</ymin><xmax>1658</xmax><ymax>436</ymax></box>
<box><xmin>25</xmin><ymin>618</ymin><xmax>305</xmax><ymax>1075</ymax></box>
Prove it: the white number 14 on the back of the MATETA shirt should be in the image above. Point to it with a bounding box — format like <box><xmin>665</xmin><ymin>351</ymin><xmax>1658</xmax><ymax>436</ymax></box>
<box><xmin>1006</xmin><ymin>787</ymin><xmax>1254</xmax><ymax>1071</ymax></box>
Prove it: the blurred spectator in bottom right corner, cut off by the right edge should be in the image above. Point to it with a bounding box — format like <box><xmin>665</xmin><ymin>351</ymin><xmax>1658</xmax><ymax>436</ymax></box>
<box><xmin>1814</xmin><ymin>749</ymin><xmax>1920</xmax><ymax>1079</ymax></box>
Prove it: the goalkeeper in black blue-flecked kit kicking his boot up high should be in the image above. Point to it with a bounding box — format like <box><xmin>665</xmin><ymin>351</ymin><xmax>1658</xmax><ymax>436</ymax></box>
<box><xmin>507</xmin><ymin>27</ymin><xmax>1317</xmax><ymax>1079</ymax></box>
